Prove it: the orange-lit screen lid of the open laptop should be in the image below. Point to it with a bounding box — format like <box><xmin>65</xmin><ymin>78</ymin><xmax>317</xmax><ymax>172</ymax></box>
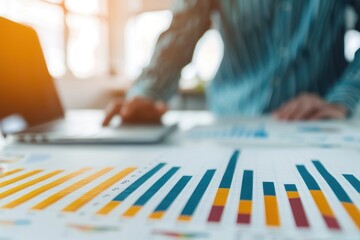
<box><xmin>0</xmin><ymin>17</ymin><xmax>64</xmax><ymax>133</ymax></box>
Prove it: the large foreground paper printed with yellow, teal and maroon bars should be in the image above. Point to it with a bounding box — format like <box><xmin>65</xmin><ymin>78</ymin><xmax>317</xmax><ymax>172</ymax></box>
<box><xmin>0</xmin><ymin>148</ymin><xmax>360</xmax><ymax>240</ymax></box>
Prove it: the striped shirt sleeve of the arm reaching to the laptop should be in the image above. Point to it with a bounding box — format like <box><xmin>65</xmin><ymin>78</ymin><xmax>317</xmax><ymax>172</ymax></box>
<box><xmin>127</xmin><ymin>0</ymin><xmax>213</xmax><ymax>101</ymax></box>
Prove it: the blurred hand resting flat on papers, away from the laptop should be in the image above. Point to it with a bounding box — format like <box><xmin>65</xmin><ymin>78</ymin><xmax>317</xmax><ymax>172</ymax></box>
<box><xmin>273</xmin><ymin>93</ymin><xmax>347</xmax><ymax>121</ymax></box>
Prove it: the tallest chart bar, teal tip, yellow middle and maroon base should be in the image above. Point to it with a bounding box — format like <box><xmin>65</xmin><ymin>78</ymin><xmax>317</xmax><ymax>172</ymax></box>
<box><xmin>208</xmin><ymin>150</ymin><xmax>240</xmax><ymax>222</ymax></box>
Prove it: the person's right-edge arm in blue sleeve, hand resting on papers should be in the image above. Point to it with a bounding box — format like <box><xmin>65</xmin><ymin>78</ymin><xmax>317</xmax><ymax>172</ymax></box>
<box><xmin>274</xmin><ymin>4</ymin><xmax>360</xmax><ymax>121</ymax></box>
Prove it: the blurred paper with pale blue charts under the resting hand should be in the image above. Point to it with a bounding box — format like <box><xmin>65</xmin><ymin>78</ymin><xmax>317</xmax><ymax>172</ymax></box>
<box><xmin>185</xmin><ymin>120</ymin><xmax>360</xmax><ymax>148</ymax></box>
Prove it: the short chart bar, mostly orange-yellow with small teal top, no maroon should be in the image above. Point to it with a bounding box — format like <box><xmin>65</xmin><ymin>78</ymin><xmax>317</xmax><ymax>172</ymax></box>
<box><xmin>263</xmin><ymin>182</ymin><xmax>280</xmax><ymax>227</ymax></box>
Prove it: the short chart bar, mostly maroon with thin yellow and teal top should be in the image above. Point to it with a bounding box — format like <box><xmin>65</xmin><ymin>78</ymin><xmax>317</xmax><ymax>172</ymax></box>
<box><xmin>285</xmin><ymin>184</ymin><xmax>310</xmax><ymax>228</ymax></box>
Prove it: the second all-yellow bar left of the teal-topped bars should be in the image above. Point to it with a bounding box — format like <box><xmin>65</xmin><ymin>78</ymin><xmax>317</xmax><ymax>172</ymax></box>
<box><xmin>32</xmin><ymin>168</ymin><xmax>113</xmax><ymax>210</ymax></box>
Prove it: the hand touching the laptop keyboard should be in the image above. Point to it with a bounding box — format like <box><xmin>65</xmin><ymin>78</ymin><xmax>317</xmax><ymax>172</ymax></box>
<box><xmin>102</xmin><ymin>97</ymin><xmax>167</xmax><ymax>126</ymax></box>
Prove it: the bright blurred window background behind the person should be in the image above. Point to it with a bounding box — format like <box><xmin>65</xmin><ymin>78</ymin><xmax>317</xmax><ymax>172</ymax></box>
<box><xmin>0</xmin><ymin>0</ymin><xmax>360</xmax><ymax>110</ymax></box>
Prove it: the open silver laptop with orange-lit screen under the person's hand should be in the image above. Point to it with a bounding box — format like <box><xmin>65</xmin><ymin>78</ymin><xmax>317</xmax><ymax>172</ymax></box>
<box><xmin>0</xmin><ymin>17</ymin><xmax>176</xmax><ymax>144</ymax></box>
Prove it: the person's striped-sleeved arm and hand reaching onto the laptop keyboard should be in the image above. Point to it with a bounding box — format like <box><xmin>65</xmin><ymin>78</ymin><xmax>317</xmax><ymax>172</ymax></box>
<box><xmin>103</xmin><ymin>0</ymin><xmax>217</xmax><ymax>126</ymax></box>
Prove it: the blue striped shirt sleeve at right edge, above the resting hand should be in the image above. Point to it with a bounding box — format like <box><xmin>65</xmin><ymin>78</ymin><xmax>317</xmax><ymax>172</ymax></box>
<box><xmin>326</xmin><ymin>0</ymin><xmax>360</xmax><ymax>116</ymax></box>
